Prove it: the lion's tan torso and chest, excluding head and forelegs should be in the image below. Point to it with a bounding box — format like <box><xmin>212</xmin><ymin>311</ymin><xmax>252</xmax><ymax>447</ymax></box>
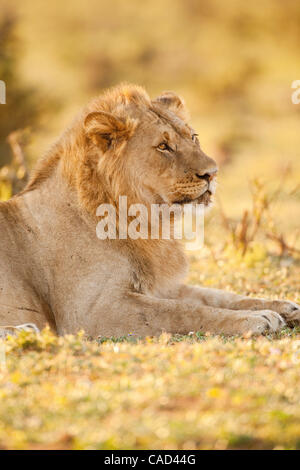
<box><xmin>0</xmin><ymin>163</ymin><xmax>186</xmax><ymax>335</ymax></box>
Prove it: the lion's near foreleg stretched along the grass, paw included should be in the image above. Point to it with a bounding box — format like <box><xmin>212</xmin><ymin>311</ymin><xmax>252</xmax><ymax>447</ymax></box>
<box><xmin>99</xmin><ymin>293</ymin><xmax>284</xmax><ymax>336</ymax></box>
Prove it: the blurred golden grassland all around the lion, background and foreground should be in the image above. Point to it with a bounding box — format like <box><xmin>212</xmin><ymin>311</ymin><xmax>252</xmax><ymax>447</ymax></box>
<box><xmin>0</xmin><ymin>0</ymin><xmax>300</xmax><ymax>450</ymax></box>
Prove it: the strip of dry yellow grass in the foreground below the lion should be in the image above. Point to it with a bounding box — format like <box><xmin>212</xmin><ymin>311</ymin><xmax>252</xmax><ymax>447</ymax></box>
<box><xmin>0</xmin><ymin>322</ymin><xmax>300</xmax><ymax>449</ymax></box>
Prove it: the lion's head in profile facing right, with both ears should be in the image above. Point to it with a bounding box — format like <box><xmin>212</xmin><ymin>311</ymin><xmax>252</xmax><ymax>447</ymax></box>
<box><xmin>77</xmin><ymin>85</ymin><xmax>217</xmax><ymax>215</ymax></box>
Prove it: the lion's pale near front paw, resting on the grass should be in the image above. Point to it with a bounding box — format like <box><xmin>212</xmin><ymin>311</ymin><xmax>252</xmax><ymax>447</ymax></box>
<box><xmin>240</xmin><ymin>310</ymin><xmax>285</xmax><ymax>335</ymax></box>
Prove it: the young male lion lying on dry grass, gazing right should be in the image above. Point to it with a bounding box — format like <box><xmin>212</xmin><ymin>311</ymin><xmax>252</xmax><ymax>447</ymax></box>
<box><xmin>0</xmin><ymin>85</ymin><xmax>300</xmax><ymax>337</ymax></box>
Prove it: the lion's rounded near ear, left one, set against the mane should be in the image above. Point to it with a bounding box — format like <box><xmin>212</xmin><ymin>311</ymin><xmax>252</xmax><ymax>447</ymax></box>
<box><xmin>84</xmin><ymin>111</ymin><xmax>136</xmax><ymax>152</ymax></box>
